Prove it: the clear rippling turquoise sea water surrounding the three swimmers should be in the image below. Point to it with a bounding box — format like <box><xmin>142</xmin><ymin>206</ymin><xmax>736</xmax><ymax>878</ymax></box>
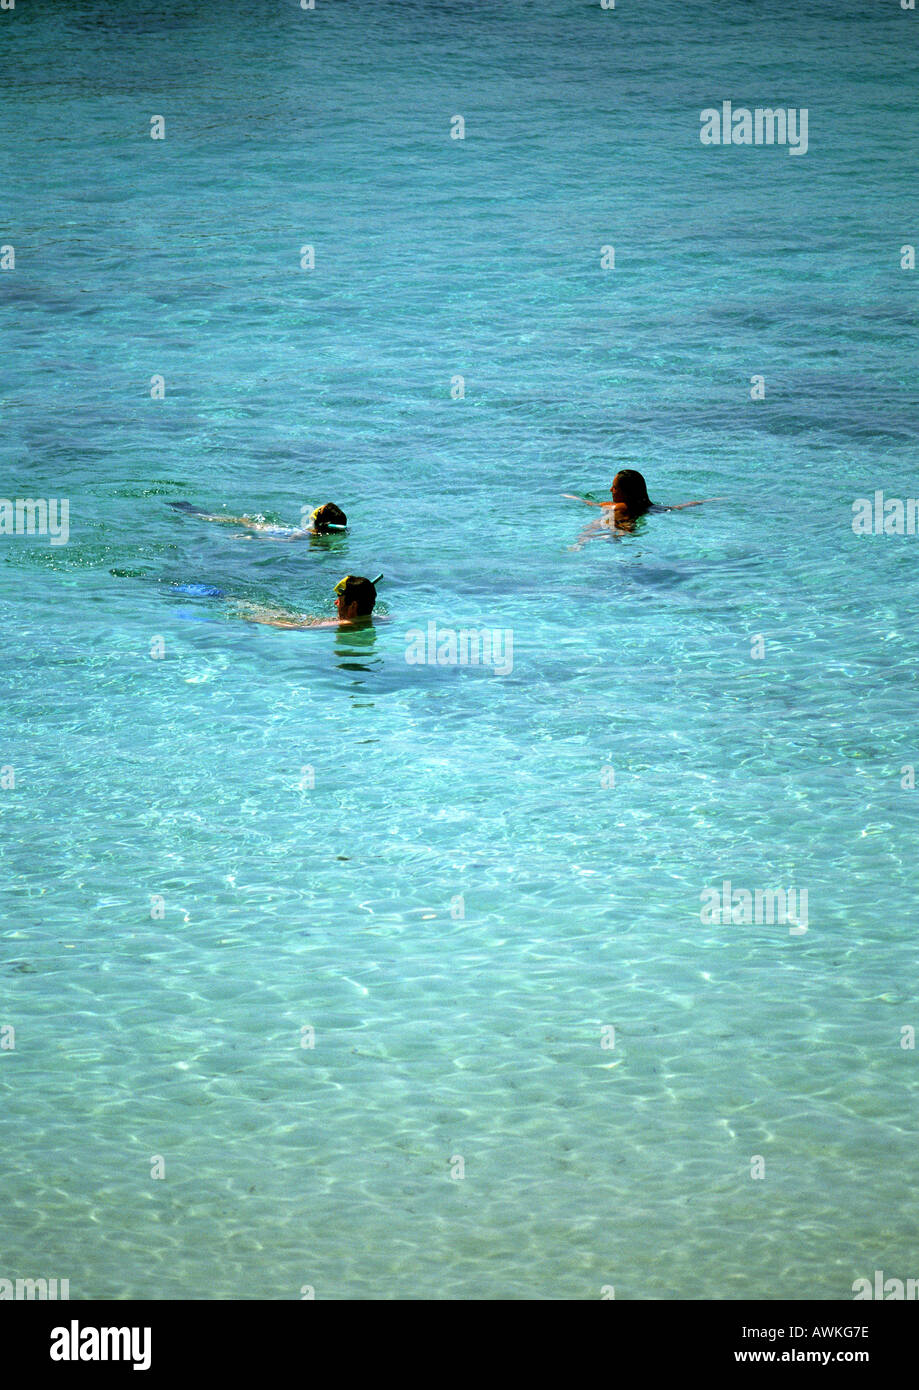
<box><xmin>0</xmin><ymin>0</ymin><xmax>919</xmax><ymax>1298</ymax></box>
